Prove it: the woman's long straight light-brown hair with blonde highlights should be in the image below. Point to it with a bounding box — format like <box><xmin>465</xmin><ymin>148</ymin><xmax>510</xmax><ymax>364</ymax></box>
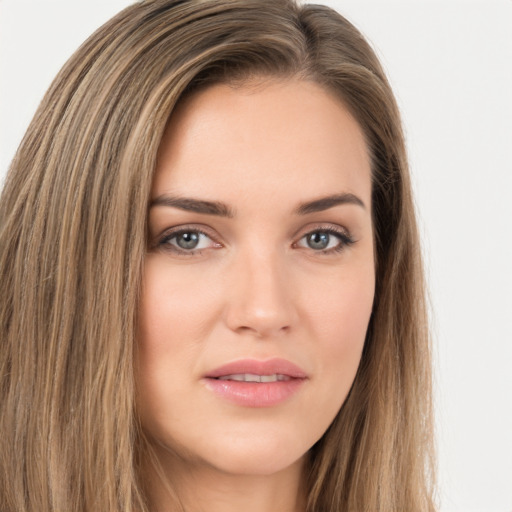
<box><xmin>0</xmin><ymin>0</ymin><xmax>434</xmax><ymax>512</ymax></box>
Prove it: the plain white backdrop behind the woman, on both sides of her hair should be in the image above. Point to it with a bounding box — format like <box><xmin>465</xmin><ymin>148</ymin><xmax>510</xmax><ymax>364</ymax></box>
<box><xmin>0</xmin><ymin>0</ymin><xmax>512</xmax><ymax>512</ymax></box>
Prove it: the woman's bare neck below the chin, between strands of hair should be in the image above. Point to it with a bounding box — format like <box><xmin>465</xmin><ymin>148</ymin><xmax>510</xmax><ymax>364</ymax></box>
<box><xmin>145</xmin><ymin>448</ymin><xmax>305</xmax><ymax>512</ymax></box>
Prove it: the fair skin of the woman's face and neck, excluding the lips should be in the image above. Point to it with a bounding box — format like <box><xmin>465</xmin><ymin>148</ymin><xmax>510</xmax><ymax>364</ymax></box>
<box><xmin>137</xmin><ymin>79</ymin><xmax>375</xmax><ymax>512</ymax></box>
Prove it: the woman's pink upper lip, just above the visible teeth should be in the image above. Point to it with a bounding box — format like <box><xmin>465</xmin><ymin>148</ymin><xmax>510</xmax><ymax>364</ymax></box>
<box><xmin>205</xmin><ymin>358</ymin><xmax>307</xmax><ymax>379</ymax></box>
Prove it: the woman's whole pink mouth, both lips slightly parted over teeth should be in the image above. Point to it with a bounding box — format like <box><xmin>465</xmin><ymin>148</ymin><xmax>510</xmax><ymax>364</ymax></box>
<box><xmin>202</xmin><ymin>358</ymin><xmax>308</xmax><ymax>407</ymax></box>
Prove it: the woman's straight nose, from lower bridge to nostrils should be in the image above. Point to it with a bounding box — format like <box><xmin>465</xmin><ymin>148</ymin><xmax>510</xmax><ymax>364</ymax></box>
<box><xmin>225</xmin><ymin>246</ymin><xmax>298</xmax><ymax>338</ymax></box>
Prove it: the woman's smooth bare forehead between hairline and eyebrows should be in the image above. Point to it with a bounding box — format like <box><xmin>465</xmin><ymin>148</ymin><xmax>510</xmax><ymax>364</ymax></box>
<box><xmin>152</xmin><ymin>79</ymin><xmax>371</xmax><ymax>210</ymax></box>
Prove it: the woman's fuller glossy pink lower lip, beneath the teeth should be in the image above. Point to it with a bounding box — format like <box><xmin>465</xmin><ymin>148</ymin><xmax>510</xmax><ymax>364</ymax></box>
<box><xmin>204</xmin><ymin>378</ymin><xmax>306</xmax><ymax>407</ymax></box>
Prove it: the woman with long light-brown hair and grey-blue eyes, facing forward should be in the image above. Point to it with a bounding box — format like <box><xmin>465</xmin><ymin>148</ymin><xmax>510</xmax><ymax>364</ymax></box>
<box><xmin>0</xmin><ymin>0</ymin><xmax>433</xmax><ymax>512</ymax></box>
